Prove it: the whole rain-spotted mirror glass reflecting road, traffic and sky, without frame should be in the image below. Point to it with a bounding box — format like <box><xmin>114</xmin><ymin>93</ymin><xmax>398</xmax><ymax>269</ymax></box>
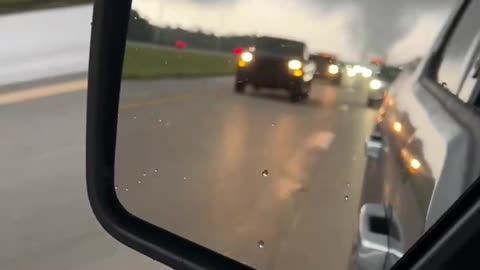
<box><xmin>115</xmin><ymin>0</ymin><xmax>473</xmax><ymax>269</ymax></box>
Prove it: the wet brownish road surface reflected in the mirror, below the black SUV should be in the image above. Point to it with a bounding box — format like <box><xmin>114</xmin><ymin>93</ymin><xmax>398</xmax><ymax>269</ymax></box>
<box><xmin>114</xmin><ymin>77</ymin><xmax>375</xmax><ymax>270</ymax></box>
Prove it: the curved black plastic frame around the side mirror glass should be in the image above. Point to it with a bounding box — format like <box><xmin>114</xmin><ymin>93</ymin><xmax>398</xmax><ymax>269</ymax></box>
<box><xmin>86</xmin><ymin>0</ymin><xmax>251</xmax><ymax>270</ymax></box>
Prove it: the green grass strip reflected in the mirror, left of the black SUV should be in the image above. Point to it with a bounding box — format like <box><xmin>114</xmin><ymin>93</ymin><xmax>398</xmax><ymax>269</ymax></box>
<box><xmin>123</xmin><ymin>45</ymin><xmax>235</xmax><ymax>80</ymax></box>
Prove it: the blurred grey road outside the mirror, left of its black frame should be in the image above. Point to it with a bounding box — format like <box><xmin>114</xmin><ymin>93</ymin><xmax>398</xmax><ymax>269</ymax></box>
<box><xmin>0</xmin><ymin>74</ymin><xmax>168</xmax><ymax>270</ymax></box>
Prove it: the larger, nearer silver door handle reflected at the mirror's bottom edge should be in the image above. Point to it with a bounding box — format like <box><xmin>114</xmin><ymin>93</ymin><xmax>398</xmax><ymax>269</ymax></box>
<box><xmin>356</xmin><ymin>204</ymin><xmax>403</xmax><ymax>269</ymax></box>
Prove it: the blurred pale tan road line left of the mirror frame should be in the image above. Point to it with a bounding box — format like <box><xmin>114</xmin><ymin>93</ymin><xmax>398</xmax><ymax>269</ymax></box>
<box><xmin>0</xmin><ymin>79</ymin><xmax>87</xmax><ymax>105</ymax></box>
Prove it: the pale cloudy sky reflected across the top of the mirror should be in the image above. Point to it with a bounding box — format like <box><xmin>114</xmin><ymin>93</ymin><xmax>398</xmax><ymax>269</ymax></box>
<box><xmin>132</xmin><ymin>0</ymin><xmax>457</xmax><ymax>63</ymax></box>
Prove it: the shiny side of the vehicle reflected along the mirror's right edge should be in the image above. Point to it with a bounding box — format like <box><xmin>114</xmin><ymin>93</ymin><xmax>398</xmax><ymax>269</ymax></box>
<box><xmin>350</xmin><ymin>0</ymin><xmax>480</xmax><ymax>269</ymax></box>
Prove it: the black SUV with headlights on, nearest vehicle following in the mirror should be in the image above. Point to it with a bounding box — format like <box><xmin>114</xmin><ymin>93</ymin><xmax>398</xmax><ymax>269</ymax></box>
<box><xmin>235</xmin><ymin>37</ymin><xmax>315</xmax><ymax>101</ymax></box>
